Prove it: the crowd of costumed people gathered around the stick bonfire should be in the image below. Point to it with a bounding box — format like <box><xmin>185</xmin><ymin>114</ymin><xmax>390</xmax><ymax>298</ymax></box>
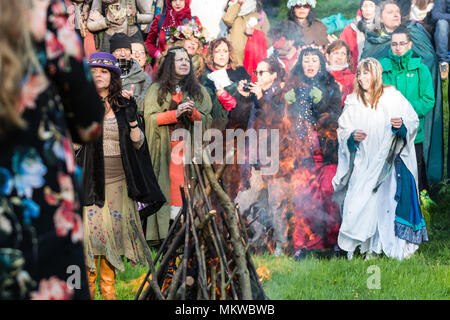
<box><xmin>0</xmin><ymin>0</ymin><xmax>450</xmax><ymax>299</ymax></box>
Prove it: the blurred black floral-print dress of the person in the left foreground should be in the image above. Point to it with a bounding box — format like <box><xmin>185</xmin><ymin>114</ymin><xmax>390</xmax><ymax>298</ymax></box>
<box><xmin>0</xmin><ymin>0</ymin><xmax>104</xmax><ymax>299</ymax></box>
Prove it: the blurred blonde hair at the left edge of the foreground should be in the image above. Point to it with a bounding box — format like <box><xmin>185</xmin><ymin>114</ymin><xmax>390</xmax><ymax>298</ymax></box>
<box><xmin>0</xmin><ymin>0</ymin><xmax>42</xmax><ymax>136</ymax></box>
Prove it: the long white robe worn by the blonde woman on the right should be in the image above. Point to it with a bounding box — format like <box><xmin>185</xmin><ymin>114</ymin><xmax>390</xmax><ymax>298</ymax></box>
<box><xmin>333</xmin><ymin>86</ymin><xmax>419</xmax><ymax>260</ymax></box>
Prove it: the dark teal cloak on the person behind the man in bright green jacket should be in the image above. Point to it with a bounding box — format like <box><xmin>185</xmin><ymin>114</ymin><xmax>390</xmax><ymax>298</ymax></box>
<box><xmin>361</xmin><ymin>22</ymin><xmax>442</xmax><ymax>184</ymax></box>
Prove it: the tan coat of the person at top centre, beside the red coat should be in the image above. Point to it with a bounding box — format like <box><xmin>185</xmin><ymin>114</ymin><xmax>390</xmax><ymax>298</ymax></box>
<box><xmin>222</xmin><ymin>2</ymin><xmax>272</xmax><ymax>66</ymax></box>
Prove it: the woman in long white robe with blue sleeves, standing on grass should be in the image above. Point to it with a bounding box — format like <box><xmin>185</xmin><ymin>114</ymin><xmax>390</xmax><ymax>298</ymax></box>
<box><xmin>333</xmin><ymin>58</ymin><xmax>428</xmax><ymax>260</ymax></box>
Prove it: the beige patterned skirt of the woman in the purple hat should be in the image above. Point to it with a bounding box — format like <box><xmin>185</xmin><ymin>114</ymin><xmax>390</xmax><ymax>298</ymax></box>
<box><xmin>83</xmin><ymin>179</ymin><xmax>147</xmax><ymax>271</ymax></box>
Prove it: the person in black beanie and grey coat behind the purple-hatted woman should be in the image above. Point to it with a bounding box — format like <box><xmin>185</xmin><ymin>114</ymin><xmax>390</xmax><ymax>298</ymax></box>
<box><xmin>109</xmin><ymin>33</ymin><xmax>152</xmax><ymax>116</ymax></box>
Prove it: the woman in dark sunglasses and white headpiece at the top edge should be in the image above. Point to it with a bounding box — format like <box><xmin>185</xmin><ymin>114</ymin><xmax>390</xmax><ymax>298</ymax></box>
<box><xmin>287</xmin><ymin>0</ymin><xmax>328</xmax><ymax>46</ymax></box>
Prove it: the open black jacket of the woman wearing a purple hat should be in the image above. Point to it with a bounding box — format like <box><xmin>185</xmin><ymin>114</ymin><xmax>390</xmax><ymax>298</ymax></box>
<box><xmin>77</xmin><ymin>98</ymin><xmax>166</xmax><ymax>213</ymax></box>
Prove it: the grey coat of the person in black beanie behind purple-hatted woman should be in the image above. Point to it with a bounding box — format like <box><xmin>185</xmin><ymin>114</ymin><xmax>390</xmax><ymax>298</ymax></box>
<box><xmin>120</xmin><ymin>59</ymin><xmax>152</xmax><ymax>116</ymax></box>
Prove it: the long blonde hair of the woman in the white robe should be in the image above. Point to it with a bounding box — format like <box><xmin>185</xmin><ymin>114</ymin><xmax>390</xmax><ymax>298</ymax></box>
<box><xmin>354</xmin><ymin>58</ymin><xmax>386</xmax><ymax>109</ymax></box>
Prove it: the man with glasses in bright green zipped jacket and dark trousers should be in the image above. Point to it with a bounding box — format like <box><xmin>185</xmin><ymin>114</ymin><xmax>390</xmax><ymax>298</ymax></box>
<box><xmin>380</xmin><ymin>27</ymin><xmax>434</xmax><ymax>191</ymax></box>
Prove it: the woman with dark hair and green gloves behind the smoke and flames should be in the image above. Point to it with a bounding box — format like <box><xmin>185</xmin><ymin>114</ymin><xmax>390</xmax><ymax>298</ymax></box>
<box><xmin>285</xmin><ymin>47</ymin><xmax>342</xmax><ymax>260</ymax></box>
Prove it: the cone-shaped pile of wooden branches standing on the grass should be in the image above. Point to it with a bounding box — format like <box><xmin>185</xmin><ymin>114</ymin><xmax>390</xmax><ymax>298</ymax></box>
<box><xmin>135</xmin><ymin>154</ymin><xmax>267</xmax><ymax>300</ymax></box>
